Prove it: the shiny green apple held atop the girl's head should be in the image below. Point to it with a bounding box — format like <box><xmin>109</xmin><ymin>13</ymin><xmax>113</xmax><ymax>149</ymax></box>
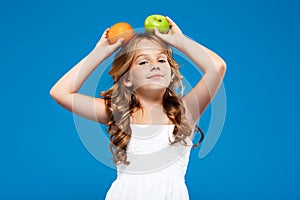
<box><xmin>144</xmin><ymin>14</ymin><xmax>169</xmax><ymax>33</ymax></box>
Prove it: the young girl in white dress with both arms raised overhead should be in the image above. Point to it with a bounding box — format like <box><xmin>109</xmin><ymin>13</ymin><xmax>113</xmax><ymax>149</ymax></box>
<box><xmin>50</xmin><ymin>17</ymin><xmax>226</xmax><ymax>200</ymax></box>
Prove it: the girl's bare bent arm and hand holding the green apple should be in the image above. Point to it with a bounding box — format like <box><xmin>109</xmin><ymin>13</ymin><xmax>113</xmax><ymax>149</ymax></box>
<box><xmin>155</xmin><ymin>17</ymin><xmax>226</xmax><ymax>124</ymax></box>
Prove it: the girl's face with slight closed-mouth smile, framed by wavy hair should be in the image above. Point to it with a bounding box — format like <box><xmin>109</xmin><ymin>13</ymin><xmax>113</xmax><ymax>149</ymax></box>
<box><xmin>128</xmin><ymin>39</ymin><xmax>171</xmax><ymax>91</ymax></box>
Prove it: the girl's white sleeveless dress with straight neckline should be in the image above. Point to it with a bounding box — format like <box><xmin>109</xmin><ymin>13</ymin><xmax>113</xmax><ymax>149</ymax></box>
<box><xmin>105</xmin><ymin>124</ymin><xmax>192</xmax><ymax>200</ymax></box>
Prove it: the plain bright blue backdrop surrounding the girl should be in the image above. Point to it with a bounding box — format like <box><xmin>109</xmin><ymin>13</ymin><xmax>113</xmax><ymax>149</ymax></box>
<box><xmin>0</xmin><ymin>0</ymin><xmax>300</xmax><ymax>200</ymax></box>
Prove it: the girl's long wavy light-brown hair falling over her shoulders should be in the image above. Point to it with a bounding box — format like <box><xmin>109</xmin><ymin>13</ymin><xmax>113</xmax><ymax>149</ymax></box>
<box><xmin>100</xmin><ymin>32</ymin><xmax>204</xmax><ymax>165</ymax></box>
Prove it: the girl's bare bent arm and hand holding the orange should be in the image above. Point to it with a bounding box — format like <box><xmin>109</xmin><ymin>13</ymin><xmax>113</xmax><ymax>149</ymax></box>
<box><xmin>50</xmin><ymin>29</ymin><xmax>123</xmax><ymax>124</ymax></box>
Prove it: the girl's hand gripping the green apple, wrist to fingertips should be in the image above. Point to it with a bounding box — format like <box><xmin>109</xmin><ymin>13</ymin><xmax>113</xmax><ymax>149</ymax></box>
<box><xmin>154</xmin><ymin>16</ymin><xmax>183</xmax><ymax>47</ymax></box>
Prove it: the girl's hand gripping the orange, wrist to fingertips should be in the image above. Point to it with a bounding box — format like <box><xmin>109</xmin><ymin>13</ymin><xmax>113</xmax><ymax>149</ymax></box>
<box><xmin>94</xmin><ymin>28</ymin><xmax>124</xmax><ymax>57</ymax></box>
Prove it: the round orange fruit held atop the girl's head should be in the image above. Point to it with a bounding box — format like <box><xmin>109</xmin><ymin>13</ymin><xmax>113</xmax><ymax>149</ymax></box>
<box><xmin>107</xmin><ymin>22</ymin><xmax>134</xmax><ymax>44</ymax></box>
